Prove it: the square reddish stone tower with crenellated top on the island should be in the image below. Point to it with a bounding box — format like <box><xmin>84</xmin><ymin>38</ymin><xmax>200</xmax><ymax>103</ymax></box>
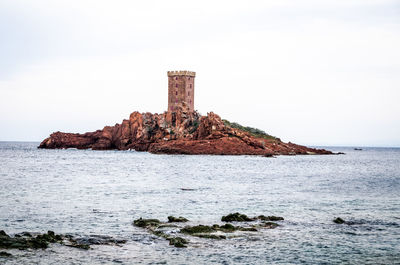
<box><xmin>168</xmin><ymin>71</ymin><xmax>196</xmax><ymax>111</ymax></box>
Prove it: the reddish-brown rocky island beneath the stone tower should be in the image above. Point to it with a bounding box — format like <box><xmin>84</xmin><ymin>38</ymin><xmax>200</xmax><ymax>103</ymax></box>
<box><xmin>39</xmin><ymin>103</ymin><xmax>332</xmax><ymax>156</ymax></box>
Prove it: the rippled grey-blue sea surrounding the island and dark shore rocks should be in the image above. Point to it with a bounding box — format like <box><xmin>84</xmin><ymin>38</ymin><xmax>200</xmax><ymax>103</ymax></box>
<box><xmin>0</xmin><ymin>142</ymin><xmax>400</xmax><ymax>264</ymax></box>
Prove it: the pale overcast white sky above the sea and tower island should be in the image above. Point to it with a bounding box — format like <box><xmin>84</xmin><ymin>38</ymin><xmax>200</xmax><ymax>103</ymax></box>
<box><xmin>0</xmin><ymin>0</ymin><xmax>400</xmax><ymax>147</ymax></box>
